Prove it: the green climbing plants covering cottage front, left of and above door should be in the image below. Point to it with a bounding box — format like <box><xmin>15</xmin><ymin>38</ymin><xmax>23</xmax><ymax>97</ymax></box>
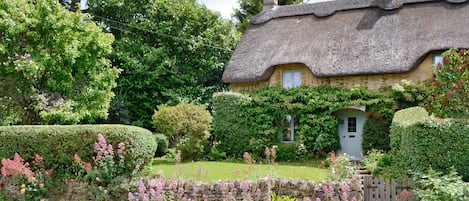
<box><xmin>213</xmin><ymin>87</ymin><xmax>392</xmax><ymax>160</ymax></box>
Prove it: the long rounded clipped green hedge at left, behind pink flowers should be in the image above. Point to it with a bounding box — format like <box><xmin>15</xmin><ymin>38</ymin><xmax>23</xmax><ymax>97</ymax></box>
<box><xmin>0</xmin><ymin>125</ymin><xmax>157</xmax><ymax>176</ymax></box>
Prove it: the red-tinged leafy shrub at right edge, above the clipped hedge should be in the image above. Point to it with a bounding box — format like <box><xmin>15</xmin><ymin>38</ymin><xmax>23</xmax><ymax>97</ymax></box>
<box><xmin>428</xmin><ymin>49</ymin><xmax>469</xmax><ymax>118</ymax></box>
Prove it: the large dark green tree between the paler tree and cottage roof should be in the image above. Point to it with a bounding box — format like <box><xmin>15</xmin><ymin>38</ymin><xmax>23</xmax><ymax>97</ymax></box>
<box><xmin>88</xmin><ymin>0</ymin><xmax>239</xmax><ymax>129</ymax></box>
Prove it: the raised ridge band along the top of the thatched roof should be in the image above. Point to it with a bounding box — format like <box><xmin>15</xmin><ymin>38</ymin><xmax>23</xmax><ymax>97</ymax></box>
<box><xmin>251</xmin><ymin>0</ymin><xmax>467</xmax><ymax>24</ymax></box>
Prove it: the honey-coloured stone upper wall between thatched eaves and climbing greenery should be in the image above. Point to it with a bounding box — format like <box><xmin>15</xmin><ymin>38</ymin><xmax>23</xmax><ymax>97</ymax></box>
<box><xmin>230</xmin><ymin>53</ymin><xmax>433</xmax><ymax>91</ymax></box>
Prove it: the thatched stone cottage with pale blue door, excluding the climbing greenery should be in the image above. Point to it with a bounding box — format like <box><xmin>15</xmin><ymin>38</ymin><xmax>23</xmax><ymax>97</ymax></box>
<box><xmin>223</xmin><ymin>0</ymin><xmax>469</xmax><ymax>159</ymax></box>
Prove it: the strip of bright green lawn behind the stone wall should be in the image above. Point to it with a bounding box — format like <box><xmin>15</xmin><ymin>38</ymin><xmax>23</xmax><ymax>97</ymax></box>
<box><xmin>143</xmin><ymin>160</ymin><xmax>329</xmax><ymax>182</ymax></box>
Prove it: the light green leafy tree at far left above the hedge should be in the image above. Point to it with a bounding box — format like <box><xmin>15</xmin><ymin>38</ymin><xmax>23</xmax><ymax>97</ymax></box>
<box><xmin>0</xmin><ymin>0</ymin><xmax>119</xmax><ymax>125</ymax></box>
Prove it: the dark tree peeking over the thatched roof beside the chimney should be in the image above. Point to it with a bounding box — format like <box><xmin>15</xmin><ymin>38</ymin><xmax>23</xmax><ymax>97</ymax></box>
<box><xmin>233</xmin><ymin>0</ymin><xmax>303</xmax><ymax>32</ymax></box>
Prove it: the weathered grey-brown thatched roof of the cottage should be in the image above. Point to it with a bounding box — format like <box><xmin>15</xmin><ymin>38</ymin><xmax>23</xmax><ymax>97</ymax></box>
<box><xmin>223</xmin><ymin>0</ymin><xmax>469</xmax><ymax>82</ymax></box>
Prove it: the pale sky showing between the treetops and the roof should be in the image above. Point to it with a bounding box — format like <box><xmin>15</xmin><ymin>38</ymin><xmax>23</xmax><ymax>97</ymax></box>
<box><xmin>198</xmin><ymin>0</ymin><xmax>329</xmax><ymax>19</ymax></box>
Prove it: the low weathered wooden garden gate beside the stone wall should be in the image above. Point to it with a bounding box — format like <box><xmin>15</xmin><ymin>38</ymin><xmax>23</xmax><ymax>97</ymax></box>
<box><xmin>363</xmin><ymin>175</ymin><xmax>410</xmax><ymax>201</ymax></box>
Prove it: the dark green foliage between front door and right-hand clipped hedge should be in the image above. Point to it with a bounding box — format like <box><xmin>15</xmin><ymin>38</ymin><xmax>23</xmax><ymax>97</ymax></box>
<box><xmin>362</xmin><ymin>114</ymin><xmax>391</xmax><ymax>152</ymax></box>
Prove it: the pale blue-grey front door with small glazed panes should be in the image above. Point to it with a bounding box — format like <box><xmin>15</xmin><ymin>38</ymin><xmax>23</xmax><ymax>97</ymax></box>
<box><xmin>337</xmin><ymin>111</ymin><xmax>366</xmax><ymax>160</ymax></box>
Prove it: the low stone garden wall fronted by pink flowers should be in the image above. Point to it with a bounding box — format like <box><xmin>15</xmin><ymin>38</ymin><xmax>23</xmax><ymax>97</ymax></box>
<box><xmin>131</xmin><ymin>178</ymin><xmax>363</xmax><ymax>201</ymax></box>
